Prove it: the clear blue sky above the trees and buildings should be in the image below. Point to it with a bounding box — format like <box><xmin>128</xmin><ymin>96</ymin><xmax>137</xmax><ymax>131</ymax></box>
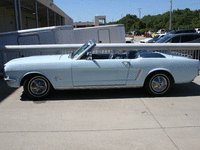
<box><xmin>54</xmin><ymin>0</ymin><xmax>200</xmax><ymax>22</ymax></box>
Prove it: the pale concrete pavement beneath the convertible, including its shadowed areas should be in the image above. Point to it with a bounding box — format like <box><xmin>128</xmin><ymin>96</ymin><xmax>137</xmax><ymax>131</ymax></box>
<box><xmin>0</xmin><ymin>77</ymin><xmax>200</xmax><ymax>150</ymax></box>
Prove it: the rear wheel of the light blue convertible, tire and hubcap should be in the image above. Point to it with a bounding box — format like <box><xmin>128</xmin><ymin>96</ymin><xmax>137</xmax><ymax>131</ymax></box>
<box><xmin>145</xmin><ymin>73</ymin><xmax>173</xmax><ymax>96</ymax></box>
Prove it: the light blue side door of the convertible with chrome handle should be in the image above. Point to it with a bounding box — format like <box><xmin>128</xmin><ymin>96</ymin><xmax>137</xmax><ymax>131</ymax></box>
<box><xmin>72</xmin><ymin>59</ymin><xmax>130</xmax><ymax>87</ymax></box>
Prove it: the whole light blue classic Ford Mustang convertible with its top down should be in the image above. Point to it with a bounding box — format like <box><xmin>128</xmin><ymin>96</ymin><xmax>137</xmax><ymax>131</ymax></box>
<box><xmin>4</xmin><ymin>40</ymin><xmax>199</xmax><ymax>99</ymax></box>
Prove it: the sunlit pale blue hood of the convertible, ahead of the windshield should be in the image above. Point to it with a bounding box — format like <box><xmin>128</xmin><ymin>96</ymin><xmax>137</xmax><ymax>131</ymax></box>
<box><xmin>6</xmin><ymin>55</ymin><xmax>69</xmax><ymax>65</ymax></box>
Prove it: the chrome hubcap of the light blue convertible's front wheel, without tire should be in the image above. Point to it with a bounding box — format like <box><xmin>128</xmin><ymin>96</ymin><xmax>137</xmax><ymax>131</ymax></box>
<box><xmin>30</xmin><ymin>79</ymin><xmax>47</xmax><ymax>95</ymax></box>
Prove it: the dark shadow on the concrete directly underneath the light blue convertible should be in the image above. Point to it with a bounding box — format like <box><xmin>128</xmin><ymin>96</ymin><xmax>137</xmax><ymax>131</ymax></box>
<box><xmin>21</xmin><ymin>82</ymin><xmax>200</xmax><ymax>101</ymax></box>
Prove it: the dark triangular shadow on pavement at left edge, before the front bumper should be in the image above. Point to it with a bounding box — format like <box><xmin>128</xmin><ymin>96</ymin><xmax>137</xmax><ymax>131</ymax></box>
<box><xmin>0</xmin><ymin>77</ymin><xmax>17</xmax><ymax>103</ymax></box>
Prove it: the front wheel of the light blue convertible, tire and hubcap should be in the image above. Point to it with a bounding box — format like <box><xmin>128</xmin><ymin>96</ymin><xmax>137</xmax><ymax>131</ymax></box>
<box><xmin>23</xmin><ymin>75</ymin><xmax>52</xmax><ymax>99</ymax></box>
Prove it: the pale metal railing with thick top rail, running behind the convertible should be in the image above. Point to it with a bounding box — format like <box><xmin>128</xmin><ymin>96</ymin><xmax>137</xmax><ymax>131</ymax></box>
<box><xmin>0</xmin><ymin>43</ymin><xmax>200</xmax><ymax>76</ymax></box>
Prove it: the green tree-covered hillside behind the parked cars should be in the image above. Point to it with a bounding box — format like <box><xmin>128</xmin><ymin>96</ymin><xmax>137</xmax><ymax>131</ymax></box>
<box><xmin>108</xmin><ymin>8</ymin><xmax>200</xmax><ymax>32</ymax></box>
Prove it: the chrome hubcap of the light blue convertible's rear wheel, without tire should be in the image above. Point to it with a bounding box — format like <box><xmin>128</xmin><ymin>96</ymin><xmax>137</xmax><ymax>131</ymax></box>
<box><xmin>151</xmin><ymin>76</ymin><xmax>168</xmax><ymax>92</ymax></box>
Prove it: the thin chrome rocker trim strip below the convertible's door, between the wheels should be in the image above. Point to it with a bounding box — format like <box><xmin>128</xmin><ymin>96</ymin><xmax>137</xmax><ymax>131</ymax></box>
<box><xmin>55</xmin><ymin>85</ymin><xmax>143</xmax><ymax>90</ymax></box>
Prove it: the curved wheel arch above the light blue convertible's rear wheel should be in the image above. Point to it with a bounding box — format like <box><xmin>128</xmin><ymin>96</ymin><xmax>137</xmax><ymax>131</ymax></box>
<box><xmin>144</xmin><ymin>69</ymin><xmax>175</xmax><ymax>84</ymax></box>
